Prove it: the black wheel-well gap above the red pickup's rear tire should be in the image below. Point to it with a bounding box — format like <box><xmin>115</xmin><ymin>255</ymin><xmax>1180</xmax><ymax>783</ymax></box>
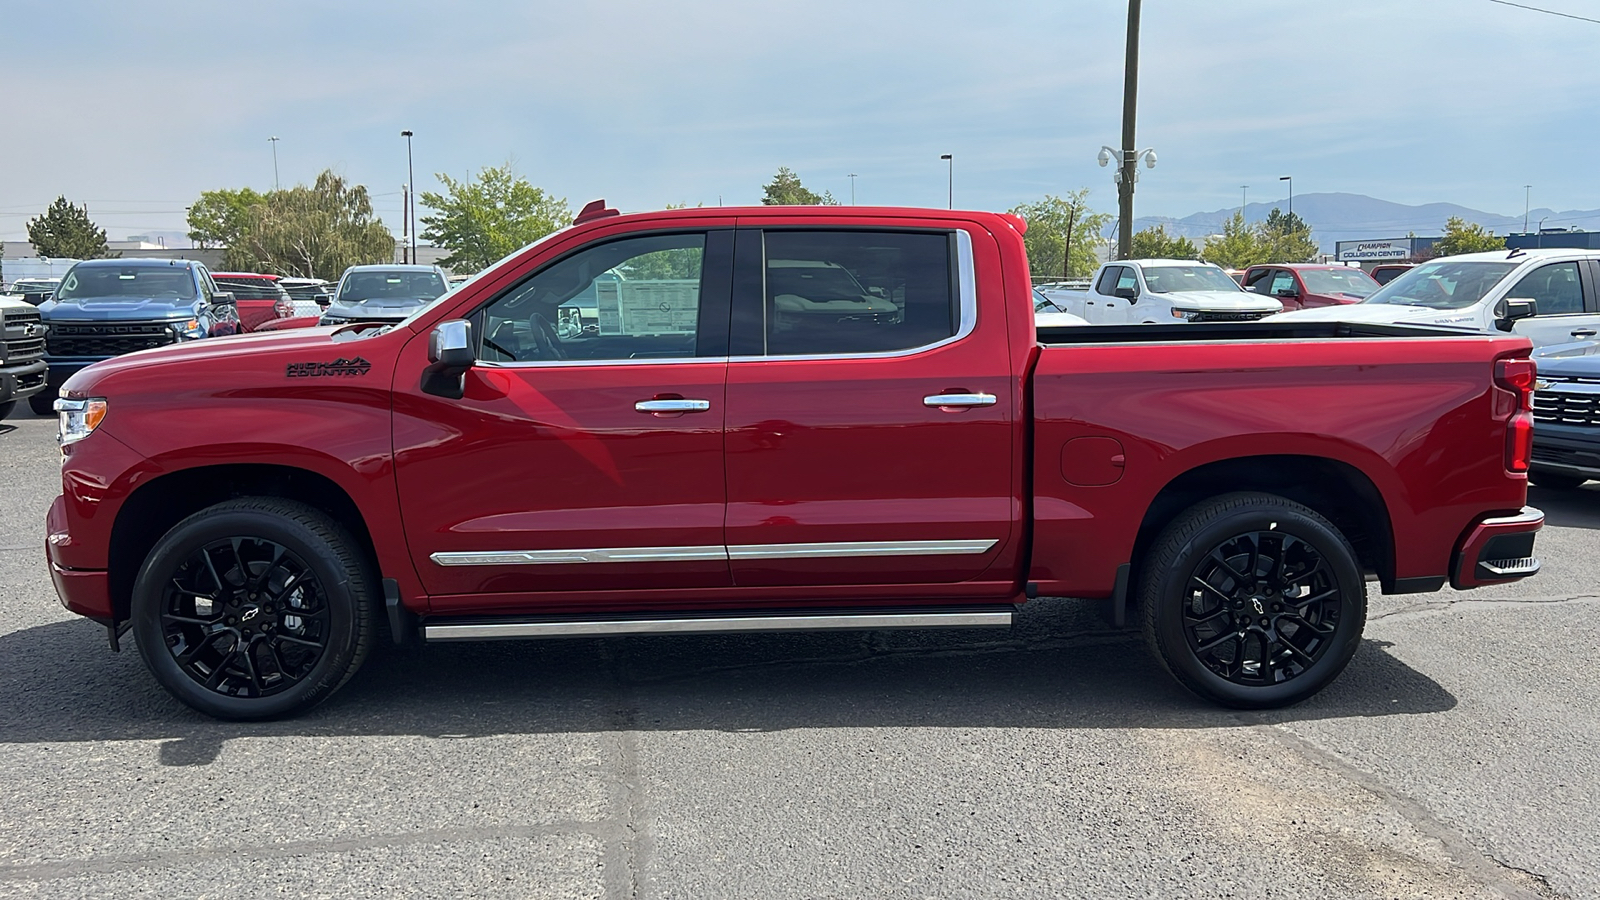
<box><xmin>1133</xmin><ymin>455</ymin><xmax>1395</xmax><ymax>591</ymax></box>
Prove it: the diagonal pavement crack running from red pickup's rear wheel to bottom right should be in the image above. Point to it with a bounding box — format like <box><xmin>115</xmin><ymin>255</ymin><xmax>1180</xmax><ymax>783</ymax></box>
<box><xmin>1237</xmin><ymin>713</ymin><xmax>1562</xmax><ymax>900</ymax></box>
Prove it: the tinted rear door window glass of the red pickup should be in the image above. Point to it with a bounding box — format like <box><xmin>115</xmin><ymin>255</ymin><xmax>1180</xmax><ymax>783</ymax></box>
<box><xmin>763</xmin><ymin>231</ymin><xmax>960</xmax><ymax>356</ymax></box>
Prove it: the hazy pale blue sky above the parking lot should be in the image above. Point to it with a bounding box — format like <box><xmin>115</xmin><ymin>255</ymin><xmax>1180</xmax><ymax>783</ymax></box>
<box><xmin>0</xmin><ymin>0</ymin><xmax>1600</xmax><ymax>240</ymax></box>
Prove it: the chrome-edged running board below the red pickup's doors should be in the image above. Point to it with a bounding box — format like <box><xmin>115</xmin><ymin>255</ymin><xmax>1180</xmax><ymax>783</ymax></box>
<box><xmin>422</xmin><ymin>607</ymin><xmax>1016</xmax><ymax>641</ymax></box>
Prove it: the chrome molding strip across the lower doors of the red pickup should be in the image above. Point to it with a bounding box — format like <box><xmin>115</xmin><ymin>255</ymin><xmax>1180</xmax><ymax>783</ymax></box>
<box><xmin>429</xmin><ymin>540</ymin><xmax>1000</xmax><ymax>565</ymax></box>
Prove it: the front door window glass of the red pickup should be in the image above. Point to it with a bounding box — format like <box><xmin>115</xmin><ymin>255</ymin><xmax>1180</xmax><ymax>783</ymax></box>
<box><xmin>474</xmin><ymin>232</ymin><xmax>706</xmax><ymax>362</ymax></box>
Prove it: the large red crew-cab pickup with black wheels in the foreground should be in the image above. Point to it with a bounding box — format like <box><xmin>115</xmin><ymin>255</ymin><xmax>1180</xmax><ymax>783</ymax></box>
<box><xmin>46</xmin><ymin>203</ymin><xmax>1544</xmax><ymax>719</ymax></box>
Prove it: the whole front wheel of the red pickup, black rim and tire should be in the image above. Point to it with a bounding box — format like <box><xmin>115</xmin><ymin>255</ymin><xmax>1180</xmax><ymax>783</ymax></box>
<box><xmin>133</xmin><ymin>496</ymin><xmax>376</xmax><ymax>719</ymax></box>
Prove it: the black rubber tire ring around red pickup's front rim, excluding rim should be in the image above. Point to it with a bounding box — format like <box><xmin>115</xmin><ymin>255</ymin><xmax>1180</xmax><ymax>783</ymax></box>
<box><xmin>131</xmin><ymin>508</ymin><xmax>357</xmax><ymax>719</ymax></box>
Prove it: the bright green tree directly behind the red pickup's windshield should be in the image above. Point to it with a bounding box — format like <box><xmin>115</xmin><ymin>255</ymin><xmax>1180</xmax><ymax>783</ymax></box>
<box><xmin>421</xmin><ymin>162</ymin><xmax>573</xmax><ymax>274</ymax></box>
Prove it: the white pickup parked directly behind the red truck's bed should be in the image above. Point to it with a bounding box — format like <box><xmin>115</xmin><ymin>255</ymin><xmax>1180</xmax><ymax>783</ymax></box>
<box><xmin>1043</xmin><ymin>259</ymin><xmax>1283</xmax><ymax>325</ymax></box>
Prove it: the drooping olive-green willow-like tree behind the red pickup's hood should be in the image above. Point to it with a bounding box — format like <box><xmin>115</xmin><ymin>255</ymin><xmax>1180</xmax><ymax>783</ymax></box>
<box><xmin>227</xmin><ymin>170</ymin><xmax>395</xmax><ymax>280</ymax></box>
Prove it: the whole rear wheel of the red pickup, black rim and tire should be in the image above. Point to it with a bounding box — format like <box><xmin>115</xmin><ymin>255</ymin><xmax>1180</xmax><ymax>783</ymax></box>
<box><xmin>1139</xmin><ymin>493</ymin><xmax>1366</xmax><ymax>709</ymax></box>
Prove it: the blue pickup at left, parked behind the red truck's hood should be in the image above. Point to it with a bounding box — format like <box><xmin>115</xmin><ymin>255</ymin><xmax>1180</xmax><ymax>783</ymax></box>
<box><xmin>27</xmin><ymin>259</ymin><xmax>238</xmax><ymax>415</ymax></box>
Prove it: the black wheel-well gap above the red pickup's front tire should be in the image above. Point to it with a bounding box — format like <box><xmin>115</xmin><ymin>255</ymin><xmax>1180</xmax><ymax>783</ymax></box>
<box><xmin>107</xmin><ymin>463</ymin><xmax>379</xmax><ymax>621</ymax></box>
